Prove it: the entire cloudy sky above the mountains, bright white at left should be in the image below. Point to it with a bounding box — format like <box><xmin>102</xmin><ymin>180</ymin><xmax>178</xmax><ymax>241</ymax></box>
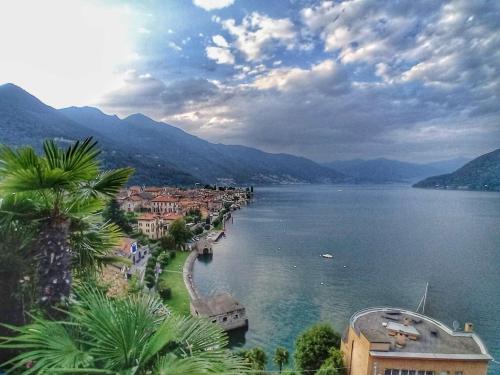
<box><xmin>0</xmin><ymin>0</ymin><xmax>500</xmax><ymax>162</ymax></box>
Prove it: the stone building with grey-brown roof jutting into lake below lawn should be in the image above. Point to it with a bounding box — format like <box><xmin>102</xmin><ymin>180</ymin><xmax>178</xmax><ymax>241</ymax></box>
<box><xmin>191</xmin><ymin>293</ymin><xmax>248</xmax><ymax>331</ymax></box>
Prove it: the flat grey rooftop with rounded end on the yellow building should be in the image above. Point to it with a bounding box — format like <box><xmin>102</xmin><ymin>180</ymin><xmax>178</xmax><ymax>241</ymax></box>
<box><xmin>350</xmin><ymin>308</ymin><xmax>491</xmax><ymax>360</ymax></box>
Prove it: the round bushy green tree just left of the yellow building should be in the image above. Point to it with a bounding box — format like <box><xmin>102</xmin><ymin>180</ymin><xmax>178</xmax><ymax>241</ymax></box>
<box><xmin>294</xmin><ymin>324</ymin><xmax>340</xmax><ymax>372</ymax></box>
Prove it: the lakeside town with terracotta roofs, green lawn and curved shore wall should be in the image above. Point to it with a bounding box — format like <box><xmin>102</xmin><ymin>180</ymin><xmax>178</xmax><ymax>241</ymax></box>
<box><xmin>106</xmin><ymin>185</ymin><xmax>253</xmax><ymax>330</ymax></box>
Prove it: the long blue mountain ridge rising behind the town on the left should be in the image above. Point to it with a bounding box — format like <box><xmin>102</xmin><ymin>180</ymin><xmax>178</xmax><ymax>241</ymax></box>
<box><xmin>0</xmin><ymin>84</ymin><xmax>346</xmax><ymax>185</ymax></box>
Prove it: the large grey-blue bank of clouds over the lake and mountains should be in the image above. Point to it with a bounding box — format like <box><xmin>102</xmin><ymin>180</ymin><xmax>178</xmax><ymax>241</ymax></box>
<box><xmin>97</xmin><ymin>1</ymin><xmax>500</xmax><ymax>160</ymax></box>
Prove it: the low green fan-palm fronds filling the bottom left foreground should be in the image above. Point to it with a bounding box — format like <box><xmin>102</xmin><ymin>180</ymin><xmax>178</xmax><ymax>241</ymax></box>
<box><xmin>0</xmin><ymin>286</ymin><xmax>247</xmax><ymax>375</ymax></box>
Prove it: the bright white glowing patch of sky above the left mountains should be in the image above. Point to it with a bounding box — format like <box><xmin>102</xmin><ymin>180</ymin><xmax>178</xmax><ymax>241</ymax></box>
<box><xmin>0</xmin><ymin>0</ymin><xmax>140</xmax><ymax>107</ymax></box>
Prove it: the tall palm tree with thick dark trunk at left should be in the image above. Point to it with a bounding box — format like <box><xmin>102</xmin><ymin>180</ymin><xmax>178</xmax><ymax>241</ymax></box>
<box><xmin>0</xmin><ymin>138</ymin><xmax>132</xmax><ymax>312</ymax></box>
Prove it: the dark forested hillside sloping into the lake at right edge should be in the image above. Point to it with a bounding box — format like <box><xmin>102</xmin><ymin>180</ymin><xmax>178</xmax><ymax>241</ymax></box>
<box><xmin>413</xmin><ymin>149</ymin><xmax>500</xmax><ymax>191</ymax></box>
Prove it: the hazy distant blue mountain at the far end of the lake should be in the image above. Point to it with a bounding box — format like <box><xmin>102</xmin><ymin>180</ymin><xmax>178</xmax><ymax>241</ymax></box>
<box><xmin>324</xmin><ymin>158</ymin><xmax>466</xmax><ymax>184</ymax></box>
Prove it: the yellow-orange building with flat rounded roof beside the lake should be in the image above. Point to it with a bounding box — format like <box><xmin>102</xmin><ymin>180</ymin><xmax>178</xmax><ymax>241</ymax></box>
<box><xmin>341</xmin><ymin>307</ymin><xmax>492</xmax><ymax>375</ymax></box>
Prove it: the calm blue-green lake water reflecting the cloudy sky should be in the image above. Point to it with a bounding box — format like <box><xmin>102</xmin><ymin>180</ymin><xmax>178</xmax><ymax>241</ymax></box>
<box><xmin>194</xmin><ymin>185</ymin><xmax>500</xmax><ymax>374</ymax></box>
